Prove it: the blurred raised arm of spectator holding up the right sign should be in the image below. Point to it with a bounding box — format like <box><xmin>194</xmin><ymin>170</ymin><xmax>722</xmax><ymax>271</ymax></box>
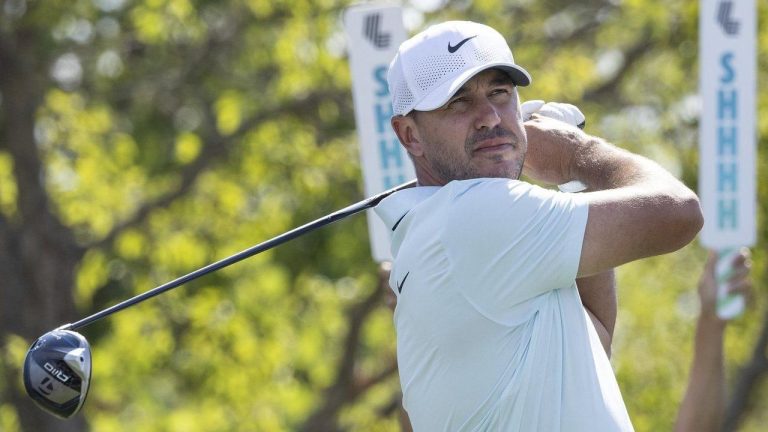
<box><xmin>675</xmin><ymin>251</ymin><xmax>750</xmax><ymax>432</ymax></box>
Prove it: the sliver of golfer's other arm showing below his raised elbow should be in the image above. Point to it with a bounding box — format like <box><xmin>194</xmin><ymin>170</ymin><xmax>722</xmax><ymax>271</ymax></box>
<box><xmin>576</xmin><ymin>270</ymin><xmax>618</xmax><ymax>357</ymax></box>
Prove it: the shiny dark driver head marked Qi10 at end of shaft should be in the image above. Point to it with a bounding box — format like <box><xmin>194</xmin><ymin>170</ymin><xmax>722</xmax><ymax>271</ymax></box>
<box><xmin>24</xmin><ymin>329</ymin><xmax>91</xmax><ymax>419</ymax></box>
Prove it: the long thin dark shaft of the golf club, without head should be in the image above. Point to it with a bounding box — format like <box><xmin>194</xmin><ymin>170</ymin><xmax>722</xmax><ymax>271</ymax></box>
<box><xmin>59</xmin><ymin>180</ymin><xmax>416</xmax><ymax>330</ymax></box>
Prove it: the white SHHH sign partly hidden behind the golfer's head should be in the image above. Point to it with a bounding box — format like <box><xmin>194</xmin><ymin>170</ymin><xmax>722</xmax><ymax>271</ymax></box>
<box><xmin>344</xmin><ymin>5</ymin><xmax>416</xmax><ymax>262</ymax></box>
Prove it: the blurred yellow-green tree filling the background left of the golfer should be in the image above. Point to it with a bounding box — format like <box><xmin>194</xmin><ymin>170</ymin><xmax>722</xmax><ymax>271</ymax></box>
<box><xmin>0</xmin><ymin>1</ymin><xmax>394</xmax><ymax>430</ymax></box>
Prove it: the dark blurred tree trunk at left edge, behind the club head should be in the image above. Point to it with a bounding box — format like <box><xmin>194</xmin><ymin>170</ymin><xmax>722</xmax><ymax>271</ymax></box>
<box><xmin>0</xmin><ymin>26</ymin><xmax>87</xmax><ymax>431</ymax></box>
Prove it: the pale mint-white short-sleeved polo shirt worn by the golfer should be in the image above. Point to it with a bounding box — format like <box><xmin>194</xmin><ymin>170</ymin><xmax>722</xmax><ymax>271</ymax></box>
<box><xmin>376</xmin><ymin>179</ymin><xmax>633</xmax><ymax>432</ymax></box>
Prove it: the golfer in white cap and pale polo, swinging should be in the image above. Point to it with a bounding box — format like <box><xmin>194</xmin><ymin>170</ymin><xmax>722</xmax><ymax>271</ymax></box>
<box><xmin>376</xmin><ymin>21</ymin><xmax>702</xmax><ymax>431</ymax></box>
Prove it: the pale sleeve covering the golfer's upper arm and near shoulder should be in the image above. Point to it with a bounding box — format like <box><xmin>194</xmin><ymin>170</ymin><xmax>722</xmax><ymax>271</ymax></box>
<box><xmin>443</xmin><ymin>179</ymin><xmax>589</xmax><ymax>307</ymax></box>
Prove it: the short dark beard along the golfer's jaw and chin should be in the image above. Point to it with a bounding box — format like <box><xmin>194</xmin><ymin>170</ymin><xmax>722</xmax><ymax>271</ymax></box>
<box><xmin>426</xmin><ymin>126</ymin><xmax>525</xmax><ymax>183</ymax></box>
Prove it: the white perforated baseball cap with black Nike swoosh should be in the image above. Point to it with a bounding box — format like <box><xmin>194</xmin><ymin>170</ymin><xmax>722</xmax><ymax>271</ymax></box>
<box><xmin>387</xmin><ymin>21</ymin><xmax>531</xmax><ymax>115</ymax></box>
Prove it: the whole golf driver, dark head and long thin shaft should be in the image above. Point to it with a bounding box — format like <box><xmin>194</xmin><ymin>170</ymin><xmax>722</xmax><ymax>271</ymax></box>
<box><xmin>24</xmin><ymin>180</ymin><xmax>416</xmax><ymax>419</ymax></box>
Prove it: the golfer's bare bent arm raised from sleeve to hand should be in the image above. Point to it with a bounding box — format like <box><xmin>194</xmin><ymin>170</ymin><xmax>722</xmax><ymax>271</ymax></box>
<box><xmin>524</xmin><ymin>114</ymin><xmax>703</xmax><ymax>277</ymax></box>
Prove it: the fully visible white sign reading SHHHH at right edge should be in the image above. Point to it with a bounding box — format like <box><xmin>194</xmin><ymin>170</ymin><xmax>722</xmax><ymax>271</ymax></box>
<box><xmin>699</xmin><ymin>0</ymin><xmax>757</xmax><ymax>249</ymax></box>
